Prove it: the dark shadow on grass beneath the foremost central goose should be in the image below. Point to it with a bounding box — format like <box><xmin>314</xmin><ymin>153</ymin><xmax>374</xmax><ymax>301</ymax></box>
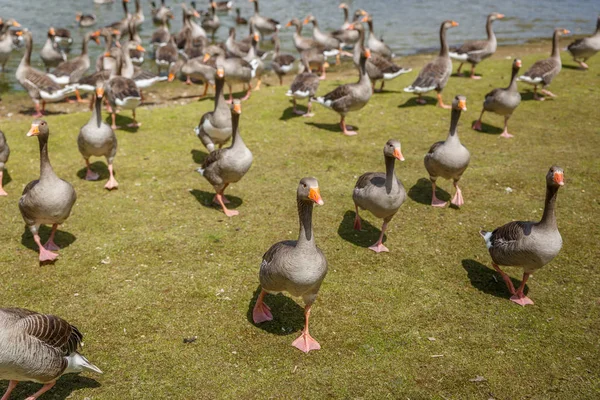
<box><xmin>246</xmin><ymin>285</ymin><xmax>304</xmax><ymax>336</ymax></box>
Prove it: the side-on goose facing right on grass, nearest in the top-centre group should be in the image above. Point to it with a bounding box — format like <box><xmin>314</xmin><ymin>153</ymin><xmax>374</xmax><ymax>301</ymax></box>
<box><xmin>316</xmin><ymin>49</ymin><xmax>373</xmax><ymax>136</ymax></box>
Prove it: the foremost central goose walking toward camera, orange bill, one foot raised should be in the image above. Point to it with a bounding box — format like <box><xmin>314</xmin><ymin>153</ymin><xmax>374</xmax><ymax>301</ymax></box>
<box><xmin>252</xmin><ymin>177</ymin><xmax>327</xmax><ymax>353</ymax></box>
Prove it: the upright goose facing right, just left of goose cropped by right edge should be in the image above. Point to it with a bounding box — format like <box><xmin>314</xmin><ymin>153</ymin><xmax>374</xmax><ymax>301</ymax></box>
<box><xmin>517</xmin><ymin>28</ymin><xmax>571</xmax><ymax>100</ymax></box>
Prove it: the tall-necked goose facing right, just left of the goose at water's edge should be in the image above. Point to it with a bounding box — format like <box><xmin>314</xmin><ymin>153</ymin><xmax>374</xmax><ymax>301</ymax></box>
<box><xmin>404</xmin><ymin>20</ymin><xmax>458</xmax><ymax>109</ymax></box>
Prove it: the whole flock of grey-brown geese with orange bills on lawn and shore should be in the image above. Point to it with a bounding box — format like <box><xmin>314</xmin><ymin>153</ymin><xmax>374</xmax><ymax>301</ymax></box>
<box><xmin>0</xmin><ymin>0</ymin><xmax>600</xmax><ymax>400</ymax></box>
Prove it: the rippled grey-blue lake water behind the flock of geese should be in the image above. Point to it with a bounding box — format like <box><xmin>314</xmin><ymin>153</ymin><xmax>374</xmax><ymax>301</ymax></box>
<box><xmin>0</xmin><ymin>0</ymin><xmax>599</xmax><ymax>91</ymax></box>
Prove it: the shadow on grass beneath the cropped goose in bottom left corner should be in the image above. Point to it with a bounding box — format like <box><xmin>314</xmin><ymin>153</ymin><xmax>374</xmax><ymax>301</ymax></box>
<box><xmin>0</xmin><ymin>374</ymin><xmax>101</xmax><ymax>400</ymax></box>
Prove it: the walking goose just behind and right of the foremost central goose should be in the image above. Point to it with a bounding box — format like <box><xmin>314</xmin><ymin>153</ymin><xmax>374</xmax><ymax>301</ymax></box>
<box><xmin>352</xmin><ymin>139</ymin><xmax>406</xmax><ymax>253</ymax></box>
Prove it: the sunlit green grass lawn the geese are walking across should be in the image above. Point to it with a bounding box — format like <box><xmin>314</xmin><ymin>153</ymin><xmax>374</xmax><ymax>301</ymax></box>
<box><xmin>0</xmin><ymin>36</ymin><xmax>600</xmax><ymax>399</ymax></box>
